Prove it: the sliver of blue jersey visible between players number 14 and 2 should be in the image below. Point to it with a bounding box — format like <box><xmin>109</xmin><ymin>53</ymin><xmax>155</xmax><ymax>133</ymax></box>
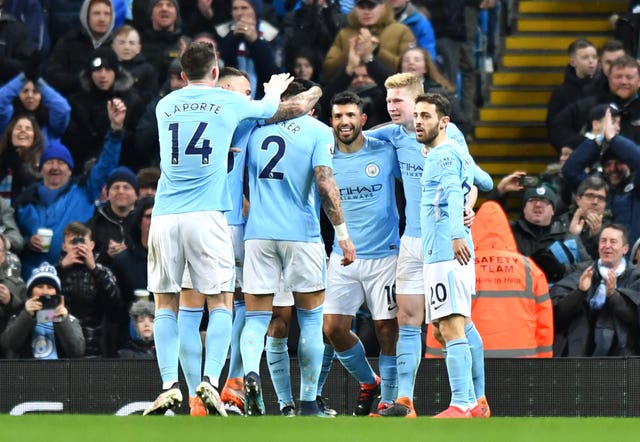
<box><xmin>226</xmin><ymin>120</ymin><xmax>256</xmax><ymax>226</ymax></box>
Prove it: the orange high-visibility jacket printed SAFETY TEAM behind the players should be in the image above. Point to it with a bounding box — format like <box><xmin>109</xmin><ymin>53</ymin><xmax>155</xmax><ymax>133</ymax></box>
<box><xmin>425</xmin><ymin>201</ymin><xmax>553</xmax><ymax>358</ymax></box>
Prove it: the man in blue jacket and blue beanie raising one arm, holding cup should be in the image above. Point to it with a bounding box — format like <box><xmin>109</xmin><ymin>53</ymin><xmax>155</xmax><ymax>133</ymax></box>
<box><xmin>16</xmin><ymin>98</ymin><xmax>126</xmax><ymax>279</ymax></box>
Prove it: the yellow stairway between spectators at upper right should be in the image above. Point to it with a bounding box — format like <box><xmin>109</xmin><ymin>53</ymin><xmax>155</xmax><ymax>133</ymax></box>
<box><xmin>469</xmin><ymin>0</ymin><xmax>628</xmax><ymax>216</ymax></box>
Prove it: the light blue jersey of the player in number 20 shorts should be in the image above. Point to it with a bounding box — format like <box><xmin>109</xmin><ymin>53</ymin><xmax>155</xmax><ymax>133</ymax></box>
<box><xmin>420</xmin><ymin>139</ymin><xmax>474</xmax><ymax>264</ymax></box>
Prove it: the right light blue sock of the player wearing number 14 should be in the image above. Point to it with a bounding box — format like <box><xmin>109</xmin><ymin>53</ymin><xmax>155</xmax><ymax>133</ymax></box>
<box><xmin>204</xmin><ymin>308</ymin><xmax>232</xmax><ymax>388</ymax></box>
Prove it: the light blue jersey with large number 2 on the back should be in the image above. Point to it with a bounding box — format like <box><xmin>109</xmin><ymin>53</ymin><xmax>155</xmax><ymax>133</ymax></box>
<box><xmin>244</xmin><ymin>115</ymin><xmax>334</xmax><ymax>242</ymax></box>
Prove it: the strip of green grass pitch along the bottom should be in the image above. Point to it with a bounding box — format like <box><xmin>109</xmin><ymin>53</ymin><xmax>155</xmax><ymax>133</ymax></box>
<box><xmin>0</xmin><ymin>414</ymin><xmax>640</xmax><ymax>442</ymax></box>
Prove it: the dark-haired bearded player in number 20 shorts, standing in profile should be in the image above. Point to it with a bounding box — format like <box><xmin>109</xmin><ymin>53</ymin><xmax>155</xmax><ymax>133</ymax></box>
<box><xmin>413</xmin><ymin>94</ymin><xmax>477</xmax><ymax>418</ymax></box>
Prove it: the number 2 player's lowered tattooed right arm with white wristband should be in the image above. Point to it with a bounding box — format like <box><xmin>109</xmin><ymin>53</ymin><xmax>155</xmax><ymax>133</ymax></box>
<box><xmin>313</xmin><ymin>166</ymin><xmax>356</xmax><ymax>266</ymax></box>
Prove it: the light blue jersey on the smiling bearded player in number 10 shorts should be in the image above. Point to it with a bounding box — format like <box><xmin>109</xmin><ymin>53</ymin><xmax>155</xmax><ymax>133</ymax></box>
<box><xmin>333</xmin><ymin>136</ymin><xmax>400</xmax><ymax>259</ymax></box>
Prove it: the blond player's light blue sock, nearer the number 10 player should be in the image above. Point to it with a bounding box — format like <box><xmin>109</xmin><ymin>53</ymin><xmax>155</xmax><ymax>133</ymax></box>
<box><xmin>396</xmin><ymin>325</ymin><xmax>422</xmax><ymax>400</ymax></box>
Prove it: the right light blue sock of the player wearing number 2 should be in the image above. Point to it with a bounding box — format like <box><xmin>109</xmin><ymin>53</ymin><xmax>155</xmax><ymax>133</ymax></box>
<box><xmin>296</xmin><ymin>305</ymin><xmax>324</xmax><ymax>402</ymax></box>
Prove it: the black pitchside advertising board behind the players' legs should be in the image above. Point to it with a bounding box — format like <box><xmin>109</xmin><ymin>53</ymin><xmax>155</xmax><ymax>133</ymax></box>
<box><xmin>0</xmin><ymin>358</ymin><xmax>640</xmax><ymax>417</ymax></box>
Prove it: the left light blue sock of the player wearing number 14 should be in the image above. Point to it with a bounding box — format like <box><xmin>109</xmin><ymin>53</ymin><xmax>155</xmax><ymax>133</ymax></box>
<box><xmin>153</xmin><ymin>308</ymin><xmax>180</xmax><ymax>386</ymax></box>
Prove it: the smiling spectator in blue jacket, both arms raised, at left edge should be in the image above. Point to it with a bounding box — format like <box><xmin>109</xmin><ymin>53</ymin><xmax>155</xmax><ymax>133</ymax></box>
<box><xmin>0</xmin><ymin>73</ymin><xmax>71</xmax><ymax>144</ymax></box>
